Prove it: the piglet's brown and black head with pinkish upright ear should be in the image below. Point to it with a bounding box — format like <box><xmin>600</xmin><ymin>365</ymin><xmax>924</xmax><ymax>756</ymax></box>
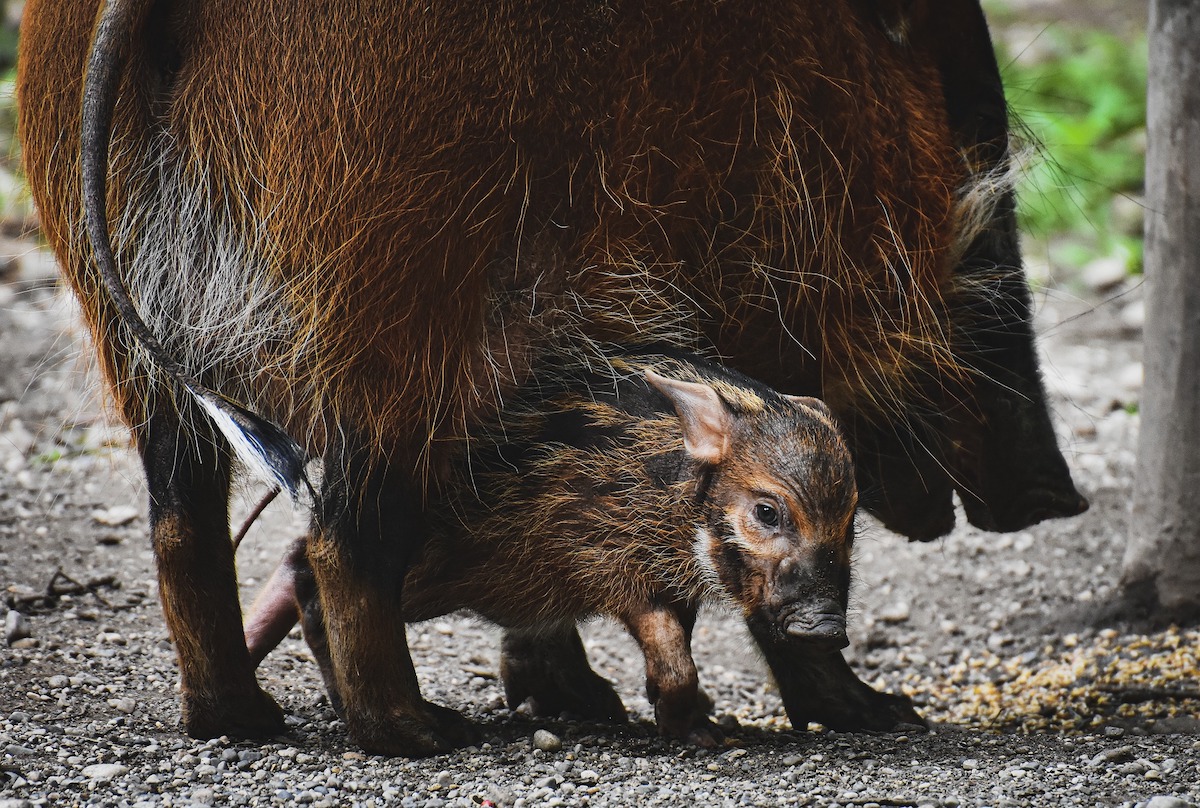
<box><xmin>647</xmin><ymin>373</ymin><xmax>858</xmax><ymax>651</ymax></box>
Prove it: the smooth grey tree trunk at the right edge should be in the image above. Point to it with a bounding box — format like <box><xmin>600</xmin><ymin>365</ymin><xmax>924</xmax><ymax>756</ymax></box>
<box><xmin>1121</xmin><ymin>0</ymin><xmax>1200</xmax><ymax>620</ymax></box>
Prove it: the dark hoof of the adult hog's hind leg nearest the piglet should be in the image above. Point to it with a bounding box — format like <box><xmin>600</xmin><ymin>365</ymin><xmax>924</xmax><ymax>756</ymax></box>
<box><xmin>346</xmin><ymin>701</ymin><xmax>479</xmax><ymax>758</ymax></box>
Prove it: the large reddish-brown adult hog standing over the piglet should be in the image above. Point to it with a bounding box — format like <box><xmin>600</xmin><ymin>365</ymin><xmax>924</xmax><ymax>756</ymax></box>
<box><xmin>18</xmin><ymin>0</ymin><xmax>1084</xmax><ymax>754</ymax></box>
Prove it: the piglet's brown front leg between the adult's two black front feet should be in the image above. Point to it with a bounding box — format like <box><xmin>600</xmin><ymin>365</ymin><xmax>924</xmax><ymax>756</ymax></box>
<box><xmin>624</xmin><ymin>606</ymin><xmax>721</xmax><ymax>748</ymax></box>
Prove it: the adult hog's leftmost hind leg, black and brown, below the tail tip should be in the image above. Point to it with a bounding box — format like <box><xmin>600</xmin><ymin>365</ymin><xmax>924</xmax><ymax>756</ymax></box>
<box><xmin>139</xmin><ymin>403</ymin><xmax>284</xmax><ymax>738</ymax></box>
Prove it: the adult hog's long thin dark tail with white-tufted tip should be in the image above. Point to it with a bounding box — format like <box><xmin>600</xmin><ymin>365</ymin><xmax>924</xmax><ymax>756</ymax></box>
<box><xmin>80</xmin><ymin>0</ymin><xmax>312</xmax><ymax>497</ymax></box>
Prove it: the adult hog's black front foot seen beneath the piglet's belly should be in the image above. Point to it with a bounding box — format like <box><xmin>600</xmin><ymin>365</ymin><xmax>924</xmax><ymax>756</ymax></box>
<box><xmin>500</xmin><ymin>623</ymin><xmax>625</xmax><ymax>723</ymax></box>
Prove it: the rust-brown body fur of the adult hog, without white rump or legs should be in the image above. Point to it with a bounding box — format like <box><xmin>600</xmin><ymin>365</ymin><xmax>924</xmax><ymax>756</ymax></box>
<box><xmin>22</xmin><ymin>0</ymin><xmax>965</xmax><ymax>463</ymax></box>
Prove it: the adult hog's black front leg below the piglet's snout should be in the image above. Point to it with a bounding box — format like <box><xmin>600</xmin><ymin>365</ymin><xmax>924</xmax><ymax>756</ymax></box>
<box><xmin>746</xmin><ymin>620</ymin><xmax>925</xmax><ymax>732</ymax></box>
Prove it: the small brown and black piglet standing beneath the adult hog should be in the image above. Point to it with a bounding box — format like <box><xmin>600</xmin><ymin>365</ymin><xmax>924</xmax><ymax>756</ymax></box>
<box><xmin>246</xmin><ymin>353</ymin><xmax>920</xmax><ymax>746</ymax></box>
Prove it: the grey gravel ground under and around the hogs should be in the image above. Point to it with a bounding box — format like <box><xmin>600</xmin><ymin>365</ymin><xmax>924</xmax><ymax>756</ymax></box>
<box><xmin>0</xmin><ymin>222</ymin><xmax>1200</xmax><ymax>808</ymax></box>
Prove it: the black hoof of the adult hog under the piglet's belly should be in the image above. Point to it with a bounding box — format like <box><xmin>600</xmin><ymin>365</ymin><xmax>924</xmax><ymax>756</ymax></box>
<box><xmin>500</xmin><ymin>645</ymin><xmax>628</xmax><ymax>724</ymax></box>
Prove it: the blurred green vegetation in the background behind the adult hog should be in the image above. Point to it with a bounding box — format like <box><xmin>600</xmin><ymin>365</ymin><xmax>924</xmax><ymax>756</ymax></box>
<box><xmin>0</xmin><ymin>0</ymin><xmax>1146</xmax><ymax>286</ymax></box>
